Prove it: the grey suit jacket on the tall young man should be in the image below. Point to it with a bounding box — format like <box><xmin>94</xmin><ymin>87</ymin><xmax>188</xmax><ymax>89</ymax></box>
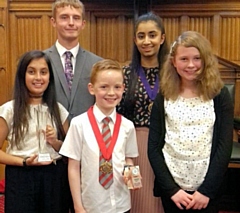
<box><xmin>44</xmin><ymin>45</ymin><xmax>102</xmax><ymax>121</ymax></box>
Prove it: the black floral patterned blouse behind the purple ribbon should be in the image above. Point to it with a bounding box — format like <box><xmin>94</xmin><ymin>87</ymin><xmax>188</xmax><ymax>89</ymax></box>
<box><xmin>117</xmin><ymin>66</ymin><xmax>159</xmax><ymax>127</ymax></box>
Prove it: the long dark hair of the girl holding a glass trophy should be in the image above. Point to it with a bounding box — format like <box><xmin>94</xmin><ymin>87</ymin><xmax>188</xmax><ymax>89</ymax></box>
<box><xmin>12</xmin><ymin>50</ymin><xmax>65</xmax><ymax>148</ymax></box>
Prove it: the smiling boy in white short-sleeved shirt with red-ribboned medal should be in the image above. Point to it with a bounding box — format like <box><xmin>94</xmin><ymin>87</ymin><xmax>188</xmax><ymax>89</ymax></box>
<box><xmin>60</xmin><ymin>59</ymin><xmax>138</xmax><ymax>213</ymax></box>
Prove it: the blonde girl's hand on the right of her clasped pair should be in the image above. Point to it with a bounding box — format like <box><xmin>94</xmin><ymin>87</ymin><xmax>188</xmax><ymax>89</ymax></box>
<box><xmin>186</xmin><ymin>191</ymin><xmax>210</xmax><ymax>210</ymax></box>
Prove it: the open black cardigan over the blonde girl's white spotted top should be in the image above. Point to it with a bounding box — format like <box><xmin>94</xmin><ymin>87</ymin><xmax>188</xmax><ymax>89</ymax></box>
<box><xmin>148</xmin><ymin>87</ymin><xmax>233</xmax><ymax>199</ymax></box>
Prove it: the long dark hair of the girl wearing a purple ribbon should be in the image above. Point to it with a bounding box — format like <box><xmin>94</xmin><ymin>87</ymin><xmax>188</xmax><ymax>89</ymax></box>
<box><xmin>124</xmin><ymin>12</ymin><xmax>169</xmax><ymax>113</ymax></box>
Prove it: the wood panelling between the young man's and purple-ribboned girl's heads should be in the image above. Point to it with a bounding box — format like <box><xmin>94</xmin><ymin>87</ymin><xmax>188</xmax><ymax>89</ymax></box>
<box><xmin>93</xmin><ymin>14</ymin><xmax>133</xmax><ymax>64</ymax></box>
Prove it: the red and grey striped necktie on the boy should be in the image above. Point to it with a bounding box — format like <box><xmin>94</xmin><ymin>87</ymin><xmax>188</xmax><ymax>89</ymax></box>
<box><xmin>99</xmin><ymin>117</ymin><xmax>113</xmax><ymax>189</ymax></box>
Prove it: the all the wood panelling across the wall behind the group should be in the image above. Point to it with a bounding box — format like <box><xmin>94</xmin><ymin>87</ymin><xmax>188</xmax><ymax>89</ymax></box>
<box><xmin>6</xmin><ymin>0</ymin><xmax>240</xmax><ymax>68</ymax></box>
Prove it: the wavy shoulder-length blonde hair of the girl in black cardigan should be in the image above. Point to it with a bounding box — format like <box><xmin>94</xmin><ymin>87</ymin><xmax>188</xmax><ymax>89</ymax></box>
<box><xmin>160</xmin><ymin>31</ymin><xmax>224</xmax><ymax>101</ymax></box>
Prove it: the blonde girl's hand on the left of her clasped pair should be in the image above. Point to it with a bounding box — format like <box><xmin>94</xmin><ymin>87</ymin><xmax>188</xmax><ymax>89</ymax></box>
<box><xmin>171</xmin><ymin>189</ymin><xmax>193</xmax><ymax>210</ymax></box>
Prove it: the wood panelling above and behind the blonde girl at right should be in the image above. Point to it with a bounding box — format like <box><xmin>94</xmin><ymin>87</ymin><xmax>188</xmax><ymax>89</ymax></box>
<box><xmin>152</xmin><ymin>1</ymin><xmax>240</xmax><ymax>64</ymax></box>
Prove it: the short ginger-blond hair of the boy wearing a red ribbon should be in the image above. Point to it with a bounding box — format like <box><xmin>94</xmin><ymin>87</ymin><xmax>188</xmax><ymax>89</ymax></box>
<box><xmin>90</xmin><ymin>59</ymin><xmax>123</xmax><ymax>84</ymax></box>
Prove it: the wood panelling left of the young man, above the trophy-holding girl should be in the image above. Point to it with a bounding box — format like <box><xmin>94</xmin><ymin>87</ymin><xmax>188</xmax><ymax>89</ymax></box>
<box><xmin>9</xmin><ymin>11</ymin><xmax>56</xmax><ymax>88</ymax></box>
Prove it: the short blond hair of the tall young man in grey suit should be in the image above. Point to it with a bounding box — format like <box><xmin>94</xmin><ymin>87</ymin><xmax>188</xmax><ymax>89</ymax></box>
<box><xmin>52</xmin><ymin>0</ymin><xmax>85</xmax><ymax>20</ymax></box>
